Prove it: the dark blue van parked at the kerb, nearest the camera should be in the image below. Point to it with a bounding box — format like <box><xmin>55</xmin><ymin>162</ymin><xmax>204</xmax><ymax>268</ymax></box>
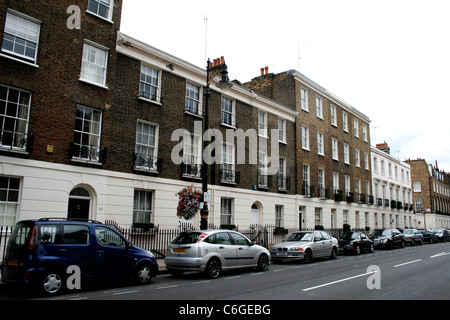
<box><xmin>2</xmin><ymin>218</ymin><xmax>158</xmax><ymax>295</ymax></box>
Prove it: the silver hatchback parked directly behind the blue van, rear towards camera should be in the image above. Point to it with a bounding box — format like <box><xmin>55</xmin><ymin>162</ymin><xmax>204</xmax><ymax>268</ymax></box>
<box><xmin>165</xmin><ymin>230</ymin><xmax>271</xmax><ymax>278</ymax></box>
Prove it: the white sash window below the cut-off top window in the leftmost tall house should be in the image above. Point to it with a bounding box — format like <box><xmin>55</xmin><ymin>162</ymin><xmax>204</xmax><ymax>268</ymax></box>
<box><xmin>79</xmin><ymin>40</ymin><xmax>109</xmax><ymax>89</ymax></box>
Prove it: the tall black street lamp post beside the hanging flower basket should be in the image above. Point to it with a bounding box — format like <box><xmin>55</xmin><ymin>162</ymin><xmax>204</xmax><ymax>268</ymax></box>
<box><xmin>200</xmin><ymin>59</ymin><xmax>233</xmax><ymax>230</ymax></box>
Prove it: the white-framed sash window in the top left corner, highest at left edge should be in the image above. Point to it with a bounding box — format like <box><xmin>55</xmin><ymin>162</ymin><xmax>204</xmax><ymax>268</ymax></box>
<box><xmin>1</xmin><ymin>9</ymin><xmax>41</xmax><ymax>66</ymax></box>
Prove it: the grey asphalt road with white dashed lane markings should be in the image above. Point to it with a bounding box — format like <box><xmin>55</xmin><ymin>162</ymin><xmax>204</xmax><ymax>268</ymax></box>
<box><xmin>0</xmin><ymin>243</ymin><xmax>450</xmax><ymax>303</ymax></box>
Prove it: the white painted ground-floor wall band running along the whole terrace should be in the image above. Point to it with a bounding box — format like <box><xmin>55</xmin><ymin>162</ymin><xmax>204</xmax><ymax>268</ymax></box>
<box><xmin>0</xmin><ymin>156</ymin><xmax>450</xmax><ymax>231</ymax></box>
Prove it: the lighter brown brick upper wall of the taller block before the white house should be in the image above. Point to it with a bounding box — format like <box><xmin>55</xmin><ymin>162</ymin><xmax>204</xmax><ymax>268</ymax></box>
<box><xmin>245</xmin><ymin>71</ymin><xmax>372</xmax><ymax>202</ymax></box>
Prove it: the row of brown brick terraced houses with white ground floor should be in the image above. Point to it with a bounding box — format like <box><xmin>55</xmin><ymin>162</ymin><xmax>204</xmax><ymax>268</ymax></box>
<box><xmin>0</xmin><ymin>0</ymin><xmax>422</xmax><ymax>230</ymax></box>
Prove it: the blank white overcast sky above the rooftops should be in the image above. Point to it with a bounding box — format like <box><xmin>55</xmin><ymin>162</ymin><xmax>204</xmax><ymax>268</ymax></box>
<box><xmin>121</xmin><ymin>0</ymin><xmax>450</xmax><ymax>172</ymax></box>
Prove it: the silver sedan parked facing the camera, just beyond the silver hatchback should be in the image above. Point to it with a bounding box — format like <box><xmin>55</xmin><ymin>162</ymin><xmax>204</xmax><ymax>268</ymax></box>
<box><xmin>270</xmin><ymin>230</ymin><xmax>339</xmax><ymax>263</ymax></box>
